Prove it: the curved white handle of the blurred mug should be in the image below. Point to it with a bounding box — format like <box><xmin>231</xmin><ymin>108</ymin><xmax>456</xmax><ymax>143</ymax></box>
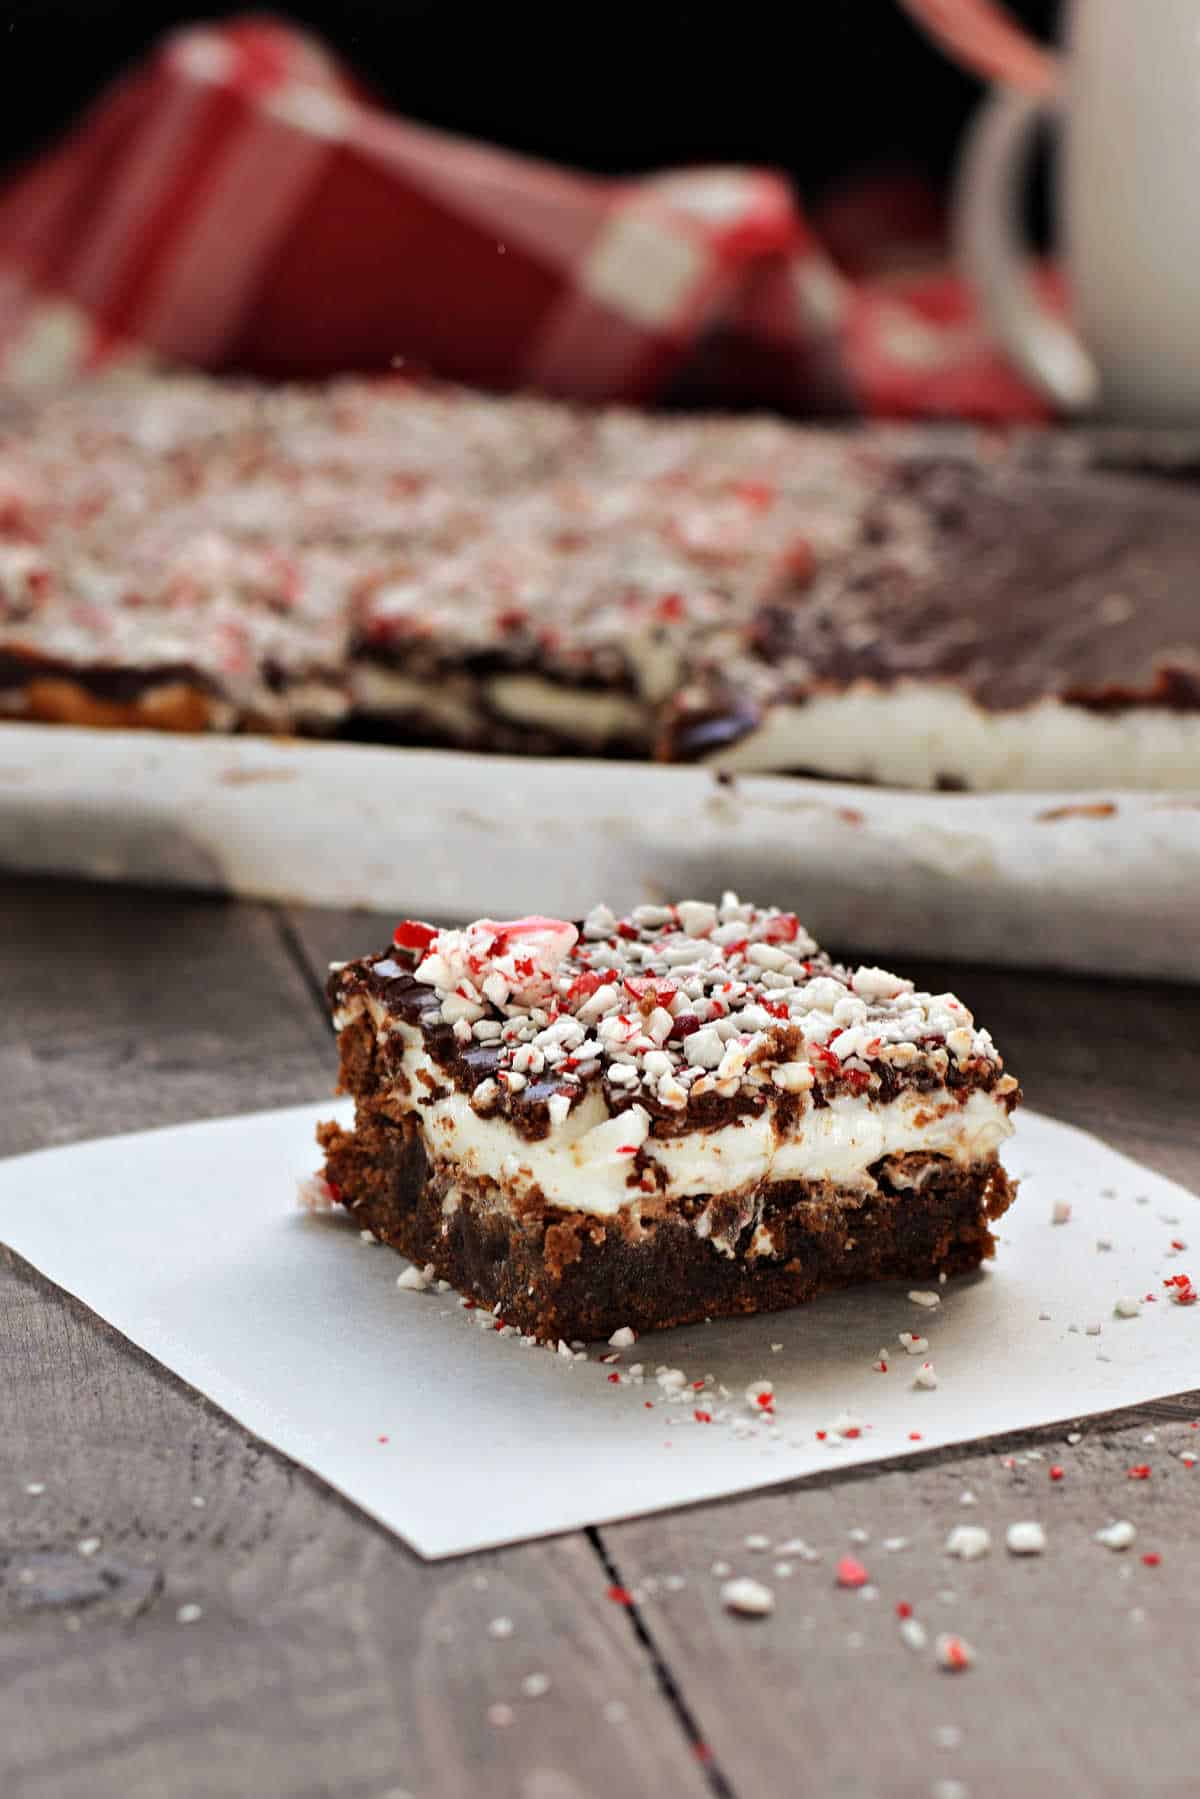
<box><xmin>952</xmin><ymin>88</ymin><xmax>1099</xmax><ymax>412</ymax></box>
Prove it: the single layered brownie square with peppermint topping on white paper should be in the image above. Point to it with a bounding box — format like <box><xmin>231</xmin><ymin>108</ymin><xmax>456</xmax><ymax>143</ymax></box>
<box><xmin>318</xmin><ymin>894</ymin><xmax>1018</xmax><ymax>1340</ymax></box>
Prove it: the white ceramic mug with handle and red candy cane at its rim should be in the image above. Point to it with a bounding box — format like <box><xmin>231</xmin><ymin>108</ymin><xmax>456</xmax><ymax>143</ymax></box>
<box><xmin>907</xmin><ymin>0</ymin><xmax>1200</xmax><ymax>425</ymax></box>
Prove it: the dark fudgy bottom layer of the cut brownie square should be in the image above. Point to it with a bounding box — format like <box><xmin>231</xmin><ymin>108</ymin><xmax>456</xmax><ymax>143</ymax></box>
<box><xmin>317</xmin><ymin>1099</ymin><xmax>1013</xmax><ymax>1340</ymax></box>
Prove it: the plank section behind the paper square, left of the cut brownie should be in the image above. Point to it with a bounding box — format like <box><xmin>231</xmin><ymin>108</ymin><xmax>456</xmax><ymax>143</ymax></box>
<box><xmin>0</xmin><ymin>880</ymin><xmax>331</xmax><ymax>1155</ymax></box>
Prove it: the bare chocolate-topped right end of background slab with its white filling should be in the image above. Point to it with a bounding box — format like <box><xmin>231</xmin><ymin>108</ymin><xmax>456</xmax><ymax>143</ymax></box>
<box><xmin>662</xmin><ymin>443</ymin><xmax>1200</xmax><ymax>788</ymax></box>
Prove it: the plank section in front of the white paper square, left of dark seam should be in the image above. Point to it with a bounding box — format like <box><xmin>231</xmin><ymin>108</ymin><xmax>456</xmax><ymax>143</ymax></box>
<box><xmin>0</xmin><ymin>1244</ymin><xmax>705</xmax><ymax>1799</ymax></box>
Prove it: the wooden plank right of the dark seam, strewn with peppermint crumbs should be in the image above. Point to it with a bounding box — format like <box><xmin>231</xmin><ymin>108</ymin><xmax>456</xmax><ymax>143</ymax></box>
<box><xmin>603</xmin><ymin>1394</ymin><xmax>1200</xmax><ymax>1799</ymax></box>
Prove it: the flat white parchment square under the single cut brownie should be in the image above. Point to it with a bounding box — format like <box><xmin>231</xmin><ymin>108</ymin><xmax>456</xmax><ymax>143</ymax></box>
<box><xmin>0</xmin><ymin>1103</ymin><xmax>1200</xmax><ymax>1556</ymax></box>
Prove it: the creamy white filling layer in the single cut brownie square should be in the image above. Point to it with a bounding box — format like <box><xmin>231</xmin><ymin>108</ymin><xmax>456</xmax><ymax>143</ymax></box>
<box><xmin>352</xmin><ymin>1004</ymin><xmax>1013</xmax><ymax>1218</ymax></box>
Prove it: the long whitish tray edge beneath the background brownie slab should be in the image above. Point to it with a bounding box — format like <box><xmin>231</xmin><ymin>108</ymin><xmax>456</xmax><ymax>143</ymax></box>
<box><xmin>0</xmin><ymin>721</ymin><xmax>1200</xmax><ymax>980</ymax></box>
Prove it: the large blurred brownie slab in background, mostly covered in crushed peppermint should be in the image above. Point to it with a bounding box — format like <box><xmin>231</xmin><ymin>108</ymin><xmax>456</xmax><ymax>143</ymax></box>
<box><xmin>0</xmin><ymin>376</ymin><xmax>1200</xmax><ymax>788</ymax></box>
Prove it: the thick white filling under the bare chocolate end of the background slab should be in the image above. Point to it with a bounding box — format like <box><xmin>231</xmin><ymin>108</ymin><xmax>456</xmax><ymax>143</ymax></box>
<box><xmin>707</xmin><ymin>682</ymin><xmax>1200</xmax><ymax>792</ymax></box>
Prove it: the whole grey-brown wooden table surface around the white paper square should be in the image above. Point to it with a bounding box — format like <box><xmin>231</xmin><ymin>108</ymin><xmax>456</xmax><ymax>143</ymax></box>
<box><xmin>0</xmin><ymin>882</ymin><xmax>1200</xmax><ymax>1799</ymax></box>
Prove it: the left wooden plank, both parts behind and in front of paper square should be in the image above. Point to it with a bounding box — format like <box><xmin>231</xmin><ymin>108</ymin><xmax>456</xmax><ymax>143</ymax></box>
<box><xmin>0</xmin><ymin>882</ymin><xmax>709</xmax><ymax>1799</ymax></box>
